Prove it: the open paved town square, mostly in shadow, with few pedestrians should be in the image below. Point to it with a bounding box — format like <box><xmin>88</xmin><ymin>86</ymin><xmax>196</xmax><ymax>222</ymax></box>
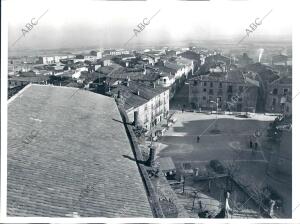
<box><xmin>158</xmin><ymin>112</ymin><xmax>275</xmax><ymax>163</ymax></box>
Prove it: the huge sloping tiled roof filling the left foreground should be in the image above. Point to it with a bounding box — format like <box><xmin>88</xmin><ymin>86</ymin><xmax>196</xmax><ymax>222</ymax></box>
<box><xmin>7</xmin><ymin>85</ymin><xmax>152</xmax><ymax>217</ymax></box>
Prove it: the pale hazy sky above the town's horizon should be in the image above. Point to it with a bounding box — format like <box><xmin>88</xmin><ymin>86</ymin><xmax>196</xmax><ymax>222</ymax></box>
<box><xmin>3</xmin><ymin>0</ymin><xmax>292</xmax><ymax>49</ymax></box>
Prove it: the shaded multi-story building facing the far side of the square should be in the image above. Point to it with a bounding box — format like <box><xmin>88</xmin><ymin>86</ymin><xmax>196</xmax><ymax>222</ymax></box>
<box><xmin>189</xmin><ymin>70</ymin><xmax>258</xmax><ymax>111</ymax></box>
